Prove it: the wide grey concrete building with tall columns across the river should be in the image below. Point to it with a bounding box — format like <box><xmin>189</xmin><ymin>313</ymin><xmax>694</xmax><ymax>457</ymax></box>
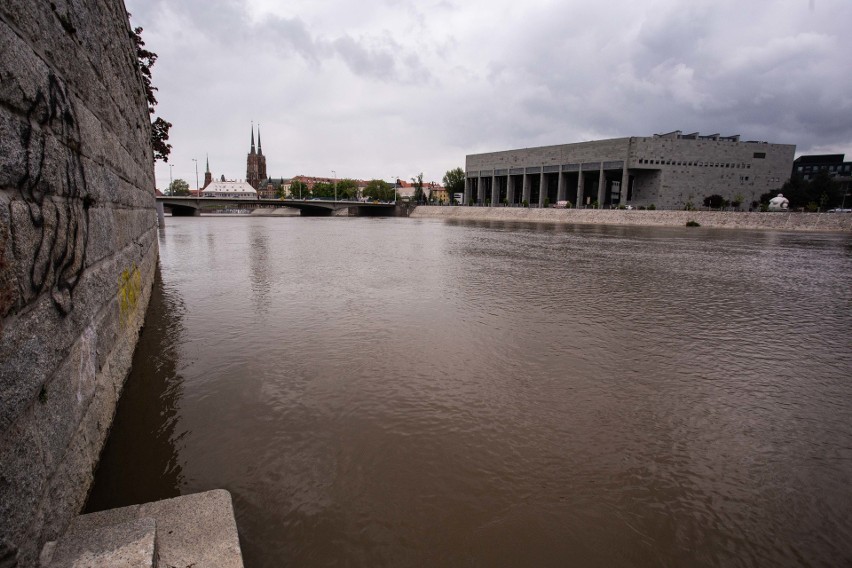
<box><xmin>465</xmin><ymin>130</ymin><xmax>796</xmax><ymax>208</ymax></box>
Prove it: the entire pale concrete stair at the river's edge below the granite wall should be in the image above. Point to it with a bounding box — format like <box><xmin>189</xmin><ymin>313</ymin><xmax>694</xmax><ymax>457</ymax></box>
<box><xmin>40</xmin><ymin>489</ymin><xmax>243</xmax><ymax>568</ymax></box>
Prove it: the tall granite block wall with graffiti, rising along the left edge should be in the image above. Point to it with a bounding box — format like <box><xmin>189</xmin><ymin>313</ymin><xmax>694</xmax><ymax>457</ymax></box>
<box><xmin>0</xmin><ymin>0</ymin><xmax>158</xmax><ymax>566</ymax></box>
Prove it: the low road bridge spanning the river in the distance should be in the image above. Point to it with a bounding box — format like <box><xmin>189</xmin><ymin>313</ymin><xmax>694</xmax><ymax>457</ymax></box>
<box><xmin>156</xmin><ymin>199</ymin><xmax>396</xmax><ymax>217</ymax></box>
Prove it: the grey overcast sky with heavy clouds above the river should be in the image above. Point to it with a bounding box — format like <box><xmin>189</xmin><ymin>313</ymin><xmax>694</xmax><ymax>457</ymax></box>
<box><xmin>125</xmin><ymin>0</ymin><xmax>852</xmax><ymax>188</ymax></box>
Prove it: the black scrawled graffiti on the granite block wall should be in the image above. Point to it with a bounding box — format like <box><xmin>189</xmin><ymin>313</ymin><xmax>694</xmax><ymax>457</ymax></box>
<box><xmin>10</xmin><ymin>72</ymin><xmax>92</xmax><ymax>315</ymax></box>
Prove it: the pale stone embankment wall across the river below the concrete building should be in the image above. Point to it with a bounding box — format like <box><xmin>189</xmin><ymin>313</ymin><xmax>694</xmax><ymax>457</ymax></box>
<box><xmin>411</xmin><ymin>205</ymin><xmax>852</xmax><ymax>233</ymax></box>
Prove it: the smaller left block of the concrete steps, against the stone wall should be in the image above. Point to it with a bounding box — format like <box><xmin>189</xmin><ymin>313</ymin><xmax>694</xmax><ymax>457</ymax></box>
<box><xmin>41</xmin><ymin>517</ymin><xmax>157</xmax><ymax>568</ymax></box>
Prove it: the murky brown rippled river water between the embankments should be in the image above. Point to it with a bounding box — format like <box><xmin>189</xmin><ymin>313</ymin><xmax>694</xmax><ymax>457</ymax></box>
<box><xmin>88</xmin><ymin>217</ymin><xmax>852</xmax><ymax>567</ymax></box>
